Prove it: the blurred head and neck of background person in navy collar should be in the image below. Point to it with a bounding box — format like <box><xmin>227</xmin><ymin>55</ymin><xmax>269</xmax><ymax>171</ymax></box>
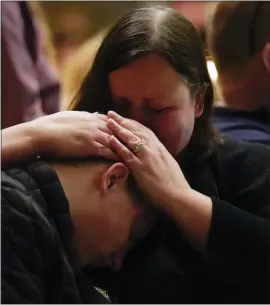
<box><xmin>206</xmin><ymin>1</ymin><xmax>270</xmax><ymax>106</ymax></box>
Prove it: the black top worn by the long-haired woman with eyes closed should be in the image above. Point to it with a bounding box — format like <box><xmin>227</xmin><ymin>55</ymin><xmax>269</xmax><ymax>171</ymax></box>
<box><xmin>92</xmin><ymin>140</ymin><xmax>270</xmax><ymax>304</ymax></box>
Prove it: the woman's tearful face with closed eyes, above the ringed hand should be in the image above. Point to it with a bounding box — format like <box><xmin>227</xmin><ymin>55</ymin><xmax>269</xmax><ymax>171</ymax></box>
<box><xmin>109</xmin><ymin>54</ymin><xmax>203</xmax><ymax>156</ymax></box>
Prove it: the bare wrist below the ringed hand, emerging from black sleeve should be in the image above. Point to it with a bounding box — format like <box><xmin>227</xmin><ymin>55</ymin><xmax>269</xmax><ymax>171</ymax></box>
<box><xmin>163</xmin><ymin>190</ymin><xmax>213</xmax><ymax>254</ymax></box>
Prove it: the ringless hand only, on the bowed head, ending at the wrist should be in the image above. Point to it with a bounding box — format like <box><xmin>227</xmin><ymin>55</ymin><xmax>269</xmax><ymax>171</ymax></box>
<box><xmin>31</xmin><ymin>111</ymin><xmax>118</xmax><ymax>159</ymax></box>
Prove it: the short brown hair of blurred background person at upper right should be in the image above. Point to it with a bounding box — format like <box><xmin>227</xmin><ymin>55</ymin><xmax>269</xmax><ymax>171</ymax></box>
<box><xmin>206</xmin><ymin>1</ymin><xmax>270</xmax><ymax>76</ymax></box>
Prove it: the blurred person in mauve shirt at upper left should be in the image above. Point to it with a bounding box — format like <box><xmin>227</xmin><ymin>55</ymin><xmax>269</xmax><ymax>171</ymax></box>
<box><xmin>1</xmin><ymin>1</ymin><xmax>60</xmax><ymax>128</ymax></box>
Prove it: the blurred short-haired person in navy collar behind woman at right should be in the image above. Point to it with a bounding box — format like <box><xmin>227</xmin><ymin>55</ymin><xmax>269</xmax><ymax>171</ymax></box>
<box><xmin>206</xmin><ymin>1</ymin><xmax>270</xmax><ymax>145</ymax></box>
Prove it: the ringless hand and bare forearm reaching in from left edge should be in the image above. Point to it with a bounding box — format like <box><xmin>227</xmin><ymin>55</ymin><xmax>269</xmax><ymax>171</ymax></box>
<box><xmin>2</xmin><ymin>111</ymin><xmax>119</xmax><ymax>165</ymax></box>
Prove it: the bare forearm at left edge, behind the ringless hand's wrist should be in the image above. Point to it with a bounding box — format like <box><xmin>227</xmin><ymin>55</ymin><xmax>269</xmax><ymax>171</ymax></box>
<box><xmin>1</xmin><ymin>123</ymin><xmax>38</xmax><ymax>165</ymax></box>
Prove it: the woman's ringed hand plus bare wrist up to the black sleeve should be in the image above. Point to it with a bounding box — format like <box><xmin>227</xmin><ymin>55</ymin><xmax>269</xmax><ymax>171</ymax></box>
<box><xmin>107</xmin><ymin>111</ymin><xmax>212</xmax><ymax>254</ymax></box>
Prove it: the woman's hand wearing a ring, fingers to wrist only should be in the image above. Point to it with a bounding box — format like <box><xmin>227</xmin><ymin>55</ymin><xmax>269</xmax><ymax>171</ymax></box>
<box><xmin>107</xmin><ymin>111</ymin><xmax>190</xmax><ymax>208</ymax></box>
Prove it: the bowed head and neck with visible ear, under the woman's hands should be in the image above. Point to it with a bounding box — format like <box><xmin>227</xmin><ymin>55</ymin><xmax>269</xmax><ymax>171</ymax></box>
<box><xmin>52</xmin><ymin>159</ymin><xmax>156</xmax><ymax>270</ymax></box>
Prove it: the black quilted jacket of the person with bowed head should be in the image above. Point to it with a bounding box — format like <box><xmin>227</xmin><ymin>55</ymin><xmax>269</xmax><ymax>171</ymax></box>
<box><xmin>1</xmin><ymin>162</ymin><xmax>107</xmax><ymax>304</ymax></box>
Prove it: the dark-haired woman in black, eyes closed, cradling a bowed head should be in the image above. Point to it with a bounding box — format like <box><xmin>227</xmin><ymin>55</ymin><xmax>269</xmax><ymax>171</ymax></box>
<box><xmin>4</xmin><ymin>7</ymin><xmax>270</xmax><ymax>303</ymax></box>
